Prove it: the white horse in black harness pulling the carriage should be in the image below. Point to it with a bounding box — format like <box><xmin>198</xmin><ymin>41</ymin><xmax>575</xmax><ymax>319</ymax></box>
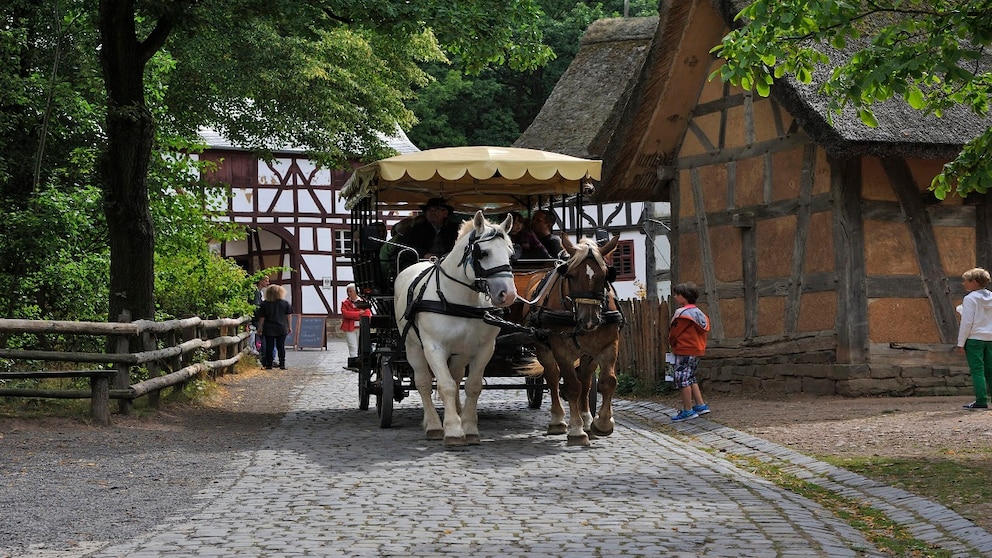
<box><xmin>395</xmin><ymin>211</ymin><xmax>517</xmax><ymax>446</ymax></box>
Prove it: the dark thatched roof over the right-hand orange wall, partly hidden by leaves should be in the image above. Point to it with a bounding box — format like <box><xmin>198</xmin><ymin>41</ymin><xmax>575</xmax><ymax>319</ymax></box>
<box><xmin>714</xmin><ymin>0</ymin><xmax>992</xmax><ymax>158</ymax></box>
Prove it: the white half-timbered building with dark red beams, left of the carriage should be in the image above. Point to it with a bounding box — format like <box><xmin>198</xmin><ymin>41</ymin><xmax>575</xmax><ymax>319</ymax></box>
<box><xmin>200</xmin><ymin>130</ymin><xmax>417</xmax><ymax>317</ymax></box>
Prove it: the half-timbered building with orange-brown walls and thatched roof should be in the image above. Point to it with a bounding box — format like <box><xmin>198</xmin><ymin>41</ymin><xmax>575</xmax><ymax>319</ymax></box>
<box><xmin>532</xmin><ymin>4</ymin><xmax>992</xmax><ymax>395</ymax></box>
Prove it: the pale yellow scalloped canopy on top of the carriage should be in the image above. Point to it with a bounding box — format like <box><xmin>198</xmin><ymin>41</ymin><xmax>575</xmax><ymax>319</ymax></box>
<box><xmin>341</xmin><ymin>146</ymin><xmax>602</xmax><ymax>212</ymax></box>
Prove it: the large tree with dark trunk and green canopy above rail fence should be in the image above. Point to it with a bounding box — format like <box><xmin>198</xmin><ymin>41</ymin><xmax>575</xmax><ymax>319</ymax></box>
<box><xmin>91</xmin><ymin>0</ymin><xmax>550</xmax><ymax>319</ymax></box>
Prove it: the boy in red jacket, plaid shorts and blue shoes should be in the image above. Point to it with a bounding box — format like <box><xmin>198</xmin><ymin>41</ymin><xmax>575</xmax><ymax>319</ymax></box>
<box><xmin>668</xmin><ymin>281</ymin><xmax>710</xmax><ymax>422</ymax></box>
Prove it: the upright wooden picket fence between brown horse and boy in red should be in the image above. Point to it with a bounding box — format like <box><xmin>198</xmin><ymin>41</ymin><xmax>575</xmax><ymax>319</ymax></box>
<box><xmin>617</xmin><ymin>299</ymin><xmax>671</xmax><ymax>384</ymax></box>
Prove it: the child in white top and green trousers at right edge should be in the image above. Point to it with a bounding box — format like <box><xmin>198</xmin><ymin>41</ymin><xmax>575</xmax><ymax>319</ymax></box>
<box><xmin>958</xmin><ymin>267</ymin><xmax>992</xmax><ymax>410</ymax></box>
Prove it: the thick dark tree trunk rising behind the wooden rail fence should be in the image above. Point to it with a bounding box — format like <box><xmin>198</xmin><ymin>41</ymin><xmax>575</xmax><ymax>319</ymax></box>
<box><xmin>100</xmin><ymin>0</ymin><xmax>155</xmax><ymax>321</ymax></box>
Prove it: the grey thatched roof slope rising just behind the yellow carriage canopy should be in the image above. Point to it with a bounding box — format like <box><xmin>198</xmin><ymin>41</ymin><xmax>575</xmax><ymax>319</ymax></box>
<box><xmin>513</xmin><ymin>16</ymin><xmax>658</xmax><ymax>159</ymax></box>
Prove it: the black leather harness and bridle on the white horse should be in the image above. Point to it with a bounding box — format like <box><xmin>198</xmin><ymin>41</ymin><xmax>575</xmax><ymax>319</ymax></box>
<box><xmin>402</xmin><ymin>230</ymin><xmax>513</xmax><ymax>346</ymax></box>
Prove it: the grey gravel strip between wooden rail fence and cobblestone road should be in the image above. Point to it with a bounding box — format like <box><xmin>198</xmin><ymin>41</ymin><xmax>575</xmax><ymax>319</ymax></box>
<box><xmin>0</xmin><ymin>353</ymin><xmax>304</xmax><ymax>558</ymax></box>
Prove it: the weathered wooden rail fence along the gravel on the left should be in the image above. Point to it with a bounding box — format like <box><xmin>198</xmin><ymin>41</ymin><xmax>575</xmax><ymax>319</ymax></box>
<box><xmin>0</xmin><ymin>315</ymin><xmax>251</xmax><ymax>425</ymax></box>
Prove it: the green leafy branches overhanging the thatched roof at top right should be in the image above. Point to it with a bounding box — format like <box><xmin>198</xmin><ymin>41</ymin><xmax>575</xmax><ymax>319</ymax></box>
<box><xmin>714</xmin><ymin>0</ymin><xmax>992</xmax><ymax>199</ymax></box>
